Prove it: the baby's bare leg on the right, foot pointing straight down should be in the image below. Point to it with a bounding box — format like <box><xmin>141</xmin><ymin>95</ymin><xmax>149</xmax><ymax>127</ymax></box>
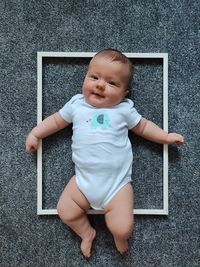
<box><xmin>105</xmin><ymin>183</ymin><xmax>134</xmax><ymax>254</ymax></box>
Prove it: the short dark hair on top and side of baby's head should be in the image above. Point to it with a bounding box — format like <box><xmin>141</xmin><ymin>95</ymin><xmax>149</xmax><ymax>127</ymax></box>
<box><xmin>94</xmin><ymin>48</ymin><xmax>133</xmax><ymax>87</ymax></box>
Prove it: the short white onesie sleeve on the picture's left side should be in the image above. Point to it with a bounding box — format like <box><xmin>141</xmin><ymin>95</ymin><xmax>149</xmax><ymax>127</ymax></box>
<box><xmin>58</xmin><ymin>94</ymin><xmax>81</xmax><ymax>122</ymax></box>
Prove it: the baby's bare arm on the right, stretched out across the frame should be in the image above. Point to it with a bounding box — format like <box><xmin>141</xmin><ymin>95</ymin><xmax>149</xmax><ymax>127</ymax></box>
<box><xmin>131</xmin><ymin>118</ymin><xmax>184</xmax><ymax>145</ymax></box>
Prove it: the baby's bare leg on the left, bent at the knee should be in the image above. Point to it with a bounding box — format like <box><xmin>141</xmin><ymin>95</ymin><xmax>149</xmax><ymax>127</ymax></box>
<box><xmin>57</xmin><ymin>176</ymin><xmax>96</xmax><ymax>258</ymax></box>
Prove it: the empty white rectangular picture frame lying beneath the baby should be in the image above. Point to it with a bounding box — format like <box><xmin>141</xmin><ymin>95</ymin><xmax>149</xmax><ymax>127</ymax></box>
<box><xmin>37</xmin><ymin>52</ymin><xmax>168</xmax><ymax>215</ymax></box>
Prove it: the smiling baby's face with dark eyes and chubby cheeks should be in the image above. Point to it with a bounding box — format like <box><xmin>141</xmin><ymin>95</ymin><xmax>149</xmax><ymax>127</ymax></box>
<box><xmin>83</xmin><ymin>56</ymin><xmax>129</xmax><ymax>108</ymax></box>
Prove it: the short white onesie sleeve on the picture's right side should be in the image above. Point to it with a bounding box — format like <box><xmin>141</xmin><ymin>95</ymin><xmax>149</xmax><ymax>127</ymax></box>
<box><xmin>126</xmin><ymin>99</ymin><xmax>142</xmax><ymax>130</ymax></box>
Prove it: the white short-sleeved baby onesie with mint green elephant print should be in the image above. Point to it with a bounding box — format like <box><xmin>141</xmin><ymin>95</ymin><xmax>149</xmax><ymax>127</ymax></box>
<box><xmin>59</xmin><ymin>94</ymin><xmax>141</xmax><ymax>210</ymax></box>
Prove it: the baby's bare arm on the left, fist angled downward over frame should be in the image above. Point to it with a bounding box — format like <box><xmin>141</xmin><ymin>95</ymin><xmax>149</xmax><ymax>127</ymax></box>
<box><xmin>26</xmin><ymin>112</ymin><xmax>70</xmax><ymax>152</ymax></box>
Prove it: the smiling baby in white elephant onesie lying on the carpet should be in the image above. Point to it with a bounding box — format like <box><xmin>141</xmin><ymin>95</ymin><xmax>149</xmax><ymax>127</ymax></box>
<box><xmin>26</xmin><ymin>49</ymin><xmax>184</xmax><ymax>258</ymax></box>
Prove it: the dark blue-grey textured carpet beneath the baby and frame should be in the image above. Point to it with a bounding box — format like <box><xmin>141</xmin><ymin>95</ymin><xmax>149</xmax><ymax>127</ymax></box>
<box><xmin>0</xmin><ymin>0</ymin><xmax>200</xmax><ymax>267</ymax></box>
